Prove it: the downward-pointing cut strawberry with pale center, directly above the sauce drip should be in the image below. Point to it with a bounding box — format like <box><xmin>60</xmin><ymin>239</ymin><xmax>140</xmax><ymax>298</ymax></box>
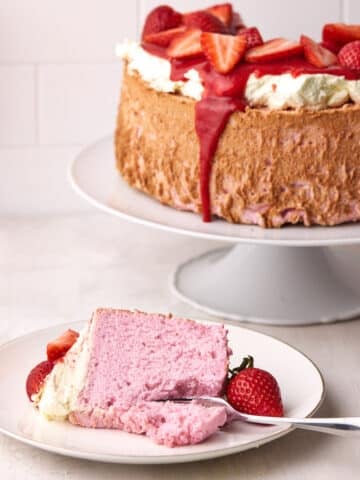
<box><xmin>201</xmin><ymin>33</ymin><xmax>246</xmax><ymax>73</ymax></box>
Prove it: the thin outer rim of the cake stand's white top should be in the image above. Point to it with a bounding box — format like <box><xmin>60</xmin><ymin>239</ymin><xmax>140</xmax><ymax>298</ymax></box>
<box><xmin>67</xmin><ymin>135</ymin><xmax>360</xmax><ymax>247</ymax></box>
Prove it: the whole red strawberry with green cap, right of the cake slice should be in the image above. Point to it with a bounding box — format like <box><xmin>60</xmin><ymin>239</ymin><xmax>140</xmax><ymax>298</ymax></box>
<box><xmin>226</xmin><ymin>356</ymin><xmax>284</xmax><ymax>417</ymax></box>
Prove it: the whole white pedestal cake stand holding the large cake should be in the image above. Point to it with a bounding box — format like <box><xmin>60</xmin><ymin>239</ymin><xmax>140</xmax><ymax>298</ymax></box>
<box><xmin>69</xmin><ymin>137</ymin><xmax>360</xmax><ymax>325</ymax></box>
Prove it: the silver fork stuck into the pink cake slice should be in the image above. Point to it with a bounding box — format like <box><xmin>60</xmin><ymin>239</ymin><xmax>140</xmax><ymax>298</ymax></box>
<box><xmin>170</xmin><ymin>396</ymin><xmax>360</xmax><ymax>437</ymax></box>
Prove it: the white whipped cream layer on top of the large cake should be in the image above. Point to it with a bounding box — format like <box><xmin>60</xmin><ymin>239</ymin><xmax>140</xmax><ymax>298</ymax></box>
<box><xmin>116</xmin><ymin>41</ymin><xmax>360</xmax><ymax>110</ymax></box>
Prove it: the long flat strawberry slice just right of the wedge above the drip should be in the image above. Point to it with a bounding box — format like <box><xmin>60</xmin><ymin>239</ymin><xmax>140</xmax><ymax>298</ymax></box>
<box><xmin>245</xmin><ymin>38</ymin><xmax>303</xmax><ymax>63</ymax></box>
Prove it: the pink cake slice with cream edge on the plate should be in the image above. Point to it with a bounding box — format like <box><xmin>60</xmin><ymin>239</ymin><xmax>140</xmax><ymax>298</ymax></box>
<box><xmin>31</xmin><ymin>309</ymin><xmax>230</xmax><ymax>447</ymax></box>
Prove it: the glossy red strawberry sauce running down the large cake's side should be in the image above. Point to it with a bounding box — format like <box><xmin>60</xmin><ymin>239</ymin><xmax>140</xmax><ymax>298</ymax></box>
<box><xmin>143</xmin><ymin>44</ymin><xmax>360</xmax><ymax>222</ymax></box>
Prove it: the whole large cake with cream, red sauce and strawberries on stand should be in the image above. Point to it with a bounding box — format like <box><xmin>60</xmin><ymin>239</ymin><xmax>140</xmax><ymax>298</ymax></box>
<box><xmin>115</xmin><ymin>3</ymin><xmax>360</xmax><ymax>228</ymax></box>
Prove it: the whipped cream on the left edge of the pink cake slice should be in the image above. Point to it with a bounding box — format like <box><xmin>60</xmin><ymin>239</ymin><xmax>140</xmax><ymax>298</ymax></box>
<box><xmin>32</xmin><ymin>322</ymin><xmax>94</xmax><ymax>420</ymax></box>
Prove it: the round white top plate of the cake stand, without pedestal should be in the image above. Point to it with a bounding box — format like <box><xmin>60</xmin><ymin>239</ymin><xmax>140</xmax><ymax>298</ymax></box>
<box><xmin>69</xmin><ymin>137</ymin><xmax>360</xmax><ymax>246</ymax></box>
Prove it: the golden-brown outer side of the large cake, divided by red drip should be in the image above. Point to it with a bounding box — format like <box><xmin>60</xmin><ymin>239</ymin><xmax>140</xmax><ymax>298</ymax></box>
<box><xmin>115</xmin><ymin>72</ymin><xmax>360</xmax><ymax>227</ymax></box>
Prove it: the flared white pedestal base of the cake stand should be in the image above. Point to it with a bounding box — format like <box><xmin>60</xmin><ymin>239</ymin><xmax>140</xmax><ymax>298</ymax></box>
<box><xmin>173</xmin><ymin>245</ymin><xmax>360</xmax><ymax>325</ymax></box>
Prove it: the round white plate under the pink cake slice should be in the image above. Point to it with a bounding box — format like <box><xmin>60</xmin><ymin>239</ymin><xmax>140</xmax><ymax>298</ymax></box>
<box><xmin>0</xmin><ymin>323</ymin><xmax>324</xmax><ymax>464</ymax></box>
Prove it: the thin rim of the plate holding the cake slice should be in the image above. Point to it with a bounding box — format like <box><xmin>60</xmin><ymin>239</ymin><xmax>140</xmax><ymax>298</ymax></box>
<box><xmin>0</xmin><ymin>318</ymin><xmax>326</xmax><ymax>465</ymax></box>
